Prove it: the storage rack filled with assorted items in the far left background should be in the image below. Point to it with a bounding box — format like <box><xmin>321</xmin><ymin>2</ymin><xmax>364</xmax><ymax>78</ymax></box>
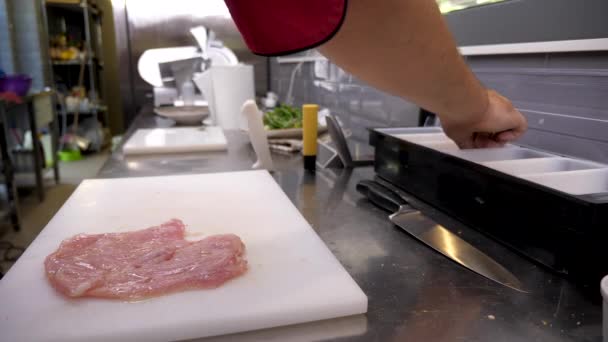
<box><xmin>43</xmin><ymin>0</ymin><xmax>108</xmax><ymax>151</ymax></box>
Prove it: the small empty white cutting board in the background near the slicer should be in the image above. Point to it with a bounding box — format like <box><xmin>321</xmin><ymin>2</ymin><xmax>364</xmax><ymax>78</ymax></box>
<box><xmin>123</xmin><ymin>126</ymin><xmax>228</xmax><ymax>154</ymax></box>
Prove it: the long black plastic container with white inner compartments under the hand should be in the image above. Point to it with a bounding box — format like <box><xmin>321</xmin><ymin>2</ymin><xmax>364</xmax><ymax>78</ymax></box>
<box><xmin>370</xmin><ymin>128</ymin><xmax>608</xmax><ymax>281</ymax></box>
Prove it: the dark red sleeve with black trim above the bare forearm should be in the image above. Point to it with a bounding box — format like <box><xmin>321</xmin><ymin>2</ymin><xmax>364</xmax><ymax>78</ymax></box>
<box><xmin>223</xmin><ymin>0</ymin><xmax>347</xmax><ymax>56</ymax></box>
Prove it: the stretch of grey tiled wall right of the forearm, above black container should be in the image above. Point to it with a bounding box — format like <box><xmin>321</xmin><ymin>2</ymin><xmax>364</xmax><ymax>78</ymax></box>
<box><xmin>467</xmin><ymin>52</ymin><xmax>608</xmax><ymax>163</ymax></box>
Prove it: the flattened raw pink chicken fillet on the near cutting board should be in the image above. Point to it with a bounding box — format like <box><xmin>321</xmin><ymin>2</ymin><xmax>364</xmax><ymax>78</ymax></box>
<box><xmin>44</xmin><ymin>219</ymin><xmax>247</xmax><ymax>300</ymax></box>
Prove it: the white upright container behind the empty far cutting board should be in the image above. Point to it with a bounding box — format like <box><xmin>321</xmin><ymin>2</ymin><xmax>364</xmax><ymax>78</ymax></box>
<box><xmin>194</xmin><ymin>64</ymin><xmax>255</xmax><ymax>129</ymax></box>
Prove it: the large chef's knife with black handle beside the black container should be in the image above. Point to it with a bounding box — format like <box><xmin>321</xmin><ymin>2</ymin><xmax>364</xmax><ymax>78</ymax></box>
<box><xmin>357</xmin><ymin>180</ymin><xmax>526</xmax><ymax>292</ymax></box>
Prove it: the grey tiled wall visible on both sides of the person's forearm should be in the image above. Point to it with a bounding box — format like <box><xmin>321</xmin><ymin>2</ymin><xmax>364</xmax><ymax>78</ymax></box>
<box><xmin>271</xmin><ymin>52</ymin><xmax>608</xmax><ymax>163</ymax></box>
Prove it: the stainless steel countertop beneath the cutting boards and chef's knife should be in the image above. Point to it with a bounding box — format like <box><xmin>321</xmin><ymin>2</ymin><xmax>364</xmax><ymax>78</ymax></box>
<box><xmin>99</xmin><ymin>111</ymin><xmax>602</xmax><ymax>342</ymax></box>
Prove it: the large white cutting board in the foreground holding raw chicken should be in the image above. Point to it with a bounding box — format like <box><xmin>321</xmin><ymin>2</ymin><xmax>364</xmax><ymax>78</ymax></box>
<box><xmin>0</xmin><ymin>171</ymin><xmax>367</xmax><ymax>342</ymax></box>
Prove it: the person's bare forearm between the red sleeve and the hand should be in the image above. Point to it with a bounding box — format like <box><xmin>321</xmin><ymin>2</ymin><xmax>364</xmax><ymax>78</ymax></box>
<box><xmin>320</xmin><ymin>0</ymin><xmax>488</xmax><ymax>122</ymax></box>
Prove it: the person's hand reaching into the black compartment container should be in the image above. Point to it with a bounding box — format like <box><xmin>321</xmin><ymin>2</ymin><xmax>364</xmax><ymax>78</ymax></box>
<box><xmin>441</xmin><ymin>90</ymin><xmax>528</xmax><ymax>148</ymax></box>
